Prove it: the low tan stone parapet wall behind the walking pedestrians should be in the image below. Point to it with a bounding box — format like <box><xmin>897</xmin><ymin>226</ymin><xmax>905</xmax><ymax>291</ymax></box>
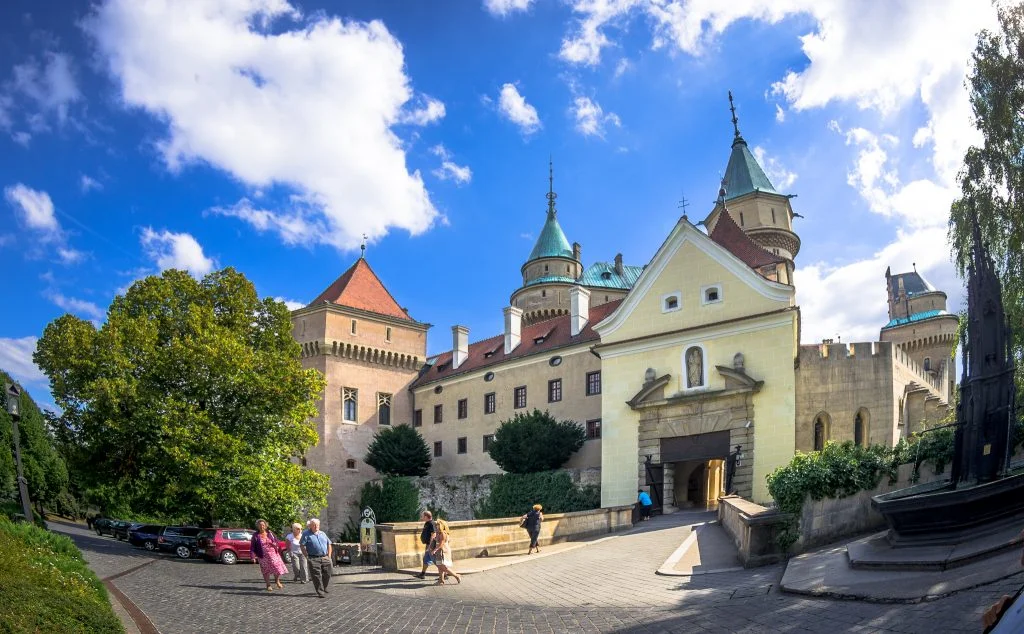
<box><xmin>377</xmin><ymin>505</ymin><xmax>633</xmax><ymax>570</ymax></box>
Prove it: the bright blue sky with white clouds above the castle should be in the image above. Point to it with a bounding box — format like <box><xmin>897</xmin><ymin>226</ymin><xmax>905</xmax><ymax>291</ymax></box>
<box><xmin>0</xmin><ymin>0</ymin><xmax>994</xmax><ymax>407</ymax></box>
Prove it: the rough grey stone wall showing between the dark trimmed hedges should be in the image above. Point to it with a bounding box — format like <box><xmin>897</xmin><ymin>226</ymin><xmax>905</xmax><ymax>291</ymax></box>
<box><xmin>411</xmin><ymin>468</ymin><xmax>601</xmax><ymax>520</ymax></box>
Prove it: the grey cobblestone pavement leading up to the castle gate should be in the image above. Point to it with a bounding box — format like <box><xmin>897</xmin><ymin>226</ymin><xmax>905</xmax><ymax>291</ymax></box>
<box><xmin>53</xmin><ymin>513</ymin><xmax>1024</xmax><ymax>634</ymax></box>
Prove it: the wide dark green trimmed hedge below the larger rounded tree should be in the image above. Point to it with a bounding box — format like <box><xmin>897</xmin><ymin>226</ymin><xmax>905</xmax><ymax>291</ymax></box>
<box><xmin>474</xmin><ymin>471</ymin><xmax>601</xmax><ymax>519</ymax></box>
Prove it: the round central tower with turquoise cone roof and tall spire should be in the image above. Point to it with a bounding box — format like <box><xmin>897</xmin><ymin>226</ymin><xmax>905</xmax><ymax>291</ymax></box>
<box><xmin>510</xmin><ymin>163</ymin><xmax>583</xmax><ymax>325</ymax></box>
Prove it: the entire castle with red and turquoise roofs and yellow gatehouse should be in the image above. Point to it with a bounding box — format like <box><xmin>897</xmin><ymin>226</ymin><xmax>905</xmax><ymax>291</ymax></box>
<box><xmin>292</xmin><ymin>95</ymin><xmax>957</xmax><ymax>531</ymax></box>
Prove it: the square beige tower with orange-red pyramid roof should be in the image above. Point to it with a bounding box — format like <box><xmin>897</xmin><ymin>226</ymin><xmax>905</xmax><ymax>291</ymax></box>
<box><xmin>292</xmin><ymin>252</ymin><xmax>430</xmax><ymax>534</ymax></box>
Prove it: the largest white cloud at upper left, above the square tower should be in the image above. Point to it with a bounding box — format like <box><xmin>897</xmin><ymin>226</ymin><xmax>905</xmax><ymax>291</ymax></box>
<box><xmin>84</xmin><ymin>0</ymin><xmax>440</xmax><ymax>248</ymax></box>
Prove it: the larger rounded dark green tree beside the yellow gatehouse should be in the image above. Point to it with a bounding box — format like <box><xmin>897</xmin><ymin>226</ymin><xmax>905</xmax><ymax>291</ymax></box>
<box><xmin>488</xmin><ymin>410</ymin><xmax>587</xmax><ymax>473</ymax></box>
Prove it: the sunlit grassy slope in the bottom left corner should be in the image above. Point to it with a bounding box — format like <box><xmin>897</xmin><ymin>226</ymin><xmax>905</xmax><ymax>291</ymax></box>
<box><xmin>0</xmin><ymin>517</ymin><xmax>124</xmax><ymax>634</ymax></box>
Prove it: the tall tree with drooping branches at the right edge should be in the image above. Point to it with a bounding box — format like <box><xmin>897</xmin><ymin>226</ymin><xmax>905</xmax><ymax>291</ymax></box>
<box><xmin>949</xmin><ymin>4</ymin><xmax>1024</xmax><ymax>385</ymax></box>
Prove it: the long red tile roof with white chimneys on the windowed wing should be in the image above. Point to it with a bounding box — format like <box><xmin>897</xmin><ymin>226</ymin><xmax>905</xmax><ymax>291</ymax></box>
<box><xmin>412</xmin><ymin>299</ymin><xmax>622</xmax><ymax>388</ymax></box>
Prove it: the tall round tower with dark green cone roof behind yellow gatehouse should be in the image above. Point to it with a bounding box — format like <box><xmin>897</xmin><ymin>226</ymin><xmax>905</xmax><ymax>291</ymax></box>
<box><xmin>705</xmin><ymin>92</ymin><xmax>800</xmax><ymax>285</ymax></box>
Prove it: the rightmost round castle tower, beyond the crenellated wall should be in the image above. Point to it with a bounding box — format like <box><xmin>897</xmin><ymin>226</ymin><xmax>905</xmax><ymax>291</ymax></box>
<box><xmin>879</xmin><ymin>266</ymin><xmax>959</xmax><ymax>403</ymax></box>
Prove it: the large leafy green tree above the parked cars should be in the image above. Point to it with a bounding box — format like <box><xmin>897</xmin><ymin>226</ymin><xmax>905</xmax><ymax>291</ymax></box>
<box><xmin>34</xmin><ymin>268</ymin><xmax>328</xmax><ymax>523</ymax></box>
